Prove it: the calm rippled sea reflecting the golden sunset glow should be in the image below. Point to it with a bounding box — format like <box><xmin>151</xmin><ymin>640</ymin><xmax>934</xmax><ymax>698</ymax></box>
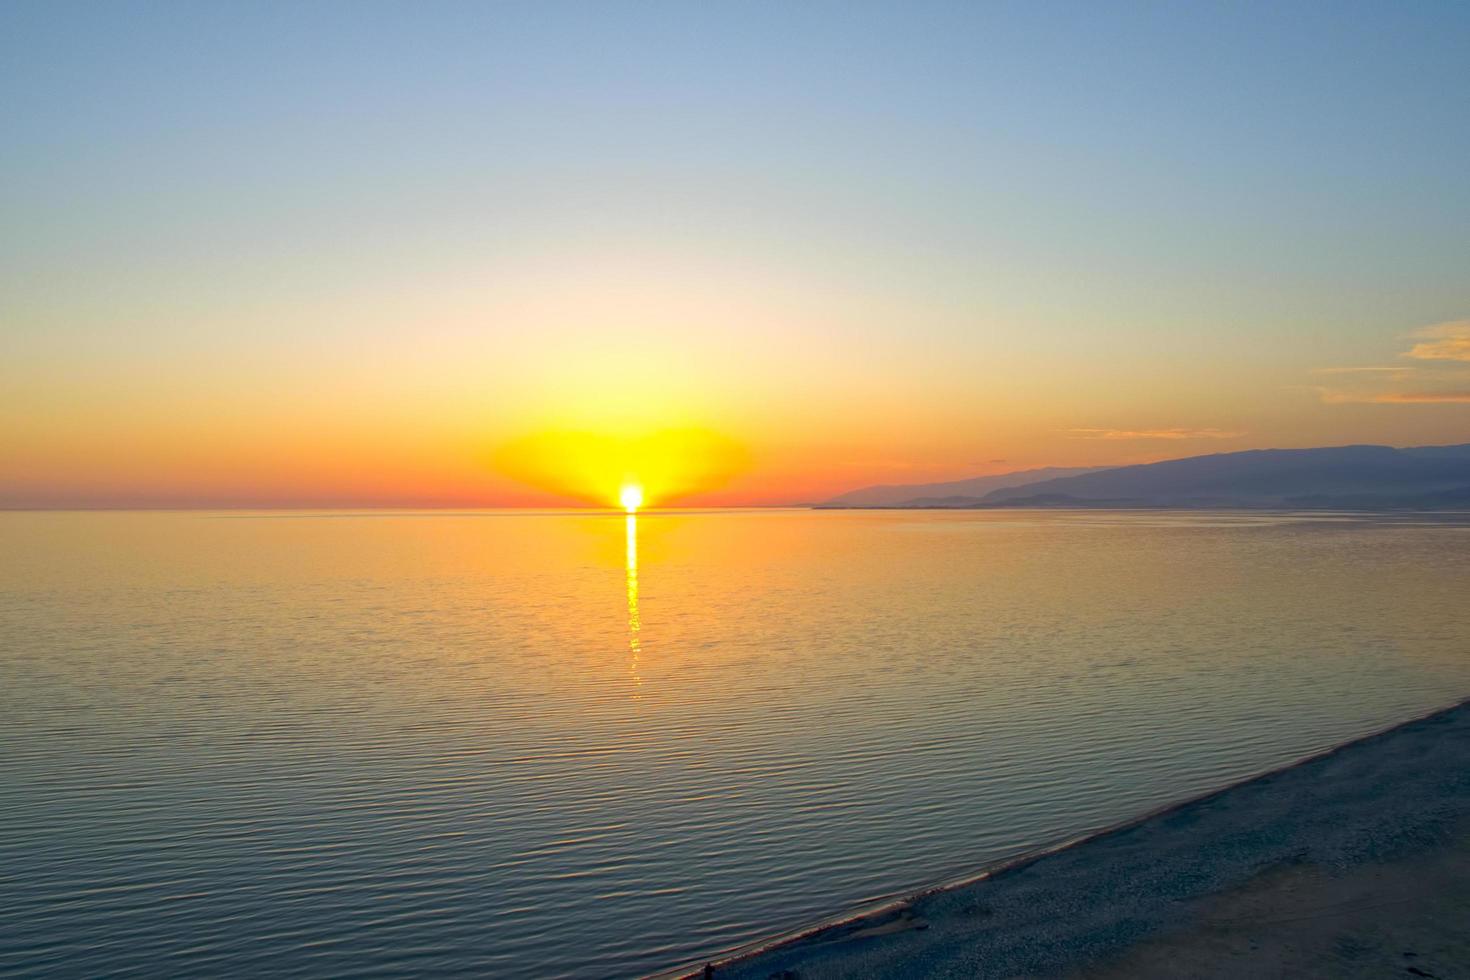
<box><xmin>0</xmin><ymin>511</ymin><xmax>1470</xmax><ymax>977</ymax></box>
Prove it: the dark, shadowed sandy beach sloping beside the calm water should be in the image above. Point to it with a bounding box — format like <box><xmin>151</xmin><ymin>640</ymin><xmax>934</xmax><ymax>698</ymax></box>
<box><xmin>695</xmin><ymin>702</ymin><xmax>1470</xmax><ymax>980</ymax></box>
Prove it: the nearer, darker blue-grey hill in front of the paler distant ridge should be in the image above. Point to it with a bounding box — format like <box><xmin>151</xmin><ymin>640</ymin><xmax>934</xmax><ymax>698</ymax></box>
<box><xmin>981</xmin><ymin>445</ymin><xmax>1470</xmax><ymax>508</ymax></box>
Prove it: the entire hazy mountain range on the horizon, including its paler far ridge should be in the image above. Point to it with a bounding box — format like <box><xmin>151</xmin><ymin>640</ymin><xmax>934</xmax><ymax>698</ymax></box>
<box><xmin>823</xmin><ymin>444</ymin><xmax>1470</xmax><ymax>510</ymax></box>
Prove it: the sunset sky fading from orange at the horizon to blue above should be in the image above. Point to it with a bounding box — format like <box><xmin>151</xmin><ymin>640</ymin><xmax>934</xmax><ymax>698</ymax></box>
<box><xmin>0</xmin><ymin>0</ymin><xmax>1470</xmax><ymax>507</ymax></box>
